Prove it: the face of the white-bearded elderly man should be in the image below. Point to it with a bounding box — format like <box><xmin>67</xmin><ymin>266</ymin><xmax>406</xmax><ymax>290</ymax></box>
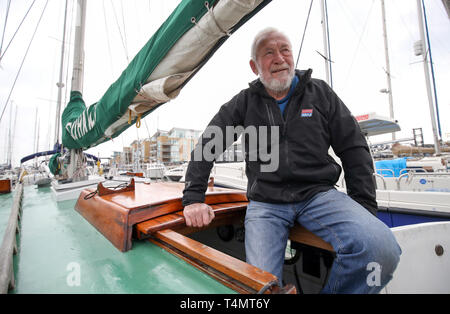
<box><xmin>250</xmin><ymin>32</ymin><xmax>295</xmax><ymax>92</ymax></box>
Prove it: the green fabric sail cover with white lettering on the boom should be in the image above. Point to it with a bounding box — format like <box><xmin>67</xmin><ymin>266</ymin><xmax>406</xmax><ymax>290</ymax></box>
<box><xmin>61</xmin><ymin>0</ymin><xmax>270</xmax><ymax>149</ymax></box>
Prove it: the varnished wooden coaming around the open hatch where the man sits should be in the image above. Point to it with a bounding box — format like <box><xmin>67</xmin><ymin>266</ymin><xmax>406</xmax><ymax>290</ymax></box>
<box><xmin>139</xmin><ymin>202</ymin><xmax>333</xmax><ymax>293</ymax></box>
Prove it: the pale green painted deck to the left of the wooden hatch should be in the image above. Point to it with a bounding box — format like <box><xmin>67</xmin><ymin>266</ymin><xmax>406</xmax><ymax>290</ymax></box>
<box><xmin>7</xmin><ymin>186</ymin><xmax>234</xmax><ymax>294</ymax></box>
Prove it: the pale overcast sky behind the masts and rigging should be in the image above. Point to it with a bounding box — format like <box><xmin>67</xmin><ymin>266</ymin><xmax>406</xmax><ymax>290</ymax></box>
<box><xmin>0</xmin><ymin>0</ymin><xmax>450</xmax><ymax>165</ymax></box>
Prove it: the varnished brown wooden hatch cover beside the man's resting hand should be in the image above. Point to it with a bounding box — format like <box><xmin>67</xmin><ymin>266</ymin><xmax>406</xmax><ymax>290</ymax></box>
<box><xmin>75</xmin><ymin>179</ymin><xmax>247</xmax><ymax>252</ymax></box>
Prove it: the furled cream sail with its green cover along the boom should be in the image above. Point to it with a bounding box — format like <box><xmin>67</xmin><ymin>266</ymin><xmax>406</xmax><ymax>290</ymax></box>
<box><xmin>62</xmin><ymin>0</ymin><xmax>271</xmax><ymax>149</ymax></box>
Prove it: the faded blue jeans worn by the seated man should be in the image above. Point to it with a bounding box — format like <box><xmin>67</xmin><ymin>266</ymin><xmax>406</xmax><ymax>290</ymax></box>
<box><xmin>245</xmin><ymin>189</ymin><xmax>401</xmax><ymax>293</ymax></box>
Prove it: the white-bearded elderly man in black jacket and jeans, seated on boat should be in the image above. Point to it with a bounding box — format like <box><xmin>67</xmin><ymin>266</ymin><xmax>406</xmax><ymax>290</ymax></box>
<box><xmin>183</xmin><ymin>28</ymin><xmax>401</xmax><ymax>293</ymax></box>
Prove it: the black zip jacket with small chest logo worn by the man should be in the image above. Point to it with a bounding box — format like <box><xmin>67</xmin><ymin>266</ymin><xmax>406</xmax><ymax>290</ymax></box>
<box><xmin>183</xmin><ymin>70</ymin><xmax>377</xmax><ymax>214</ymax></box>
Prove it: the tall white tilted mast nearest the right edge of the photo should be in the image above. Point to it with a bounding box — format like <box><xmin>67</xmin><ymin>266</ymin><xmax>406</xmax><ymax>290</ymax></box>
<box><xmin>417</xmin><ymin>0</ymin><xmax>441</xmax><ymax>156</ymax></box>
